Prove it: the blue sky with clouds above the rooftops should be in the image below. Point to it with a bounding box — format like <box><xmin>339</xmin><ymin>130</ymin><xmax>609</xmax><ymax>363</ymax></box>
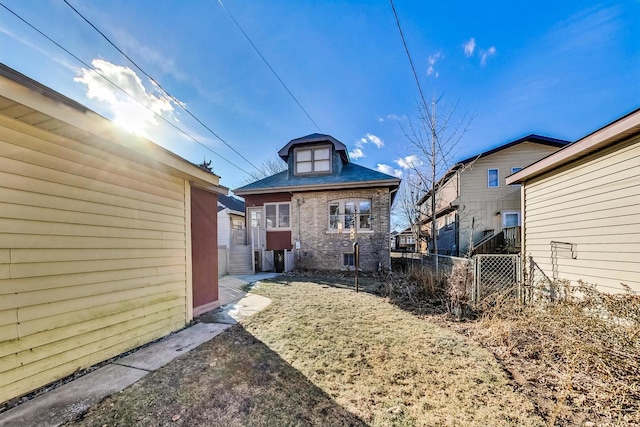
<box><xmin>0</xmin><ymin>0</ymin><xmax>640</xmax><ymax>188</ymax></box>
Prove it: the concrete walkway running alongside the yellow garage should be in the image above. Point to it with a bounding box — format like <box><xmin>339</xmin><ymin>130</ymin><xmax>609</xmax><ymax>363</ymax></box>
<box><xmin>0</xmin><ymin>273</ymin><xmax>279</xmax><ymax>427</ymax></box>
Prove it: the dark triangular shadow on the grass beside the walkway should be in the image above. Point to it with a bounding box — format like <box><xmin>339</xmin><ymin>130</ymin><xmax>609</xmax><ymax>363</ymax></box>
<box><xmin>68</xmin><ymin>324</ymin><xmax>366</xmax><ymax>426</ymax></box>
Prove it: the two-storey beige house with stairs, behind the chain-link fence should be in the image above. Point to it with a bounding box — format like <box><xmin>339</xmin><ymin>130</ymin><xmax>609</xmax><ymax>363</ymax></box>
<box><xmin>419</xmin><ymin>135</ymin><xmax>569</xmax><ymax>256</ymax></box>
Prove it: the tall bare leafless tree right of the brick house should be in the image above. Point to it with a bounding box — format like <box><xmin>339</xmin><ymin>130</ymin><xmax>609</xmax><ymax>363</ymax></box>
<box><xmin>402</xmin><ymin>96</ymin><xmax>472</xmax><ymax>273</ymax></box>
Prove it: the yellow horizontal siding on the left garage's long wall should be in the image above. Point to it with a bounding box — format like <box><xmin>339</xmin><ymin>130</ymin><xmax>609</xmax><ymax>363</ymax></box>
<box><xmin>0</xmin><ymin>117</ymin><xmax>190</xmax><ymax>402</ymax></box>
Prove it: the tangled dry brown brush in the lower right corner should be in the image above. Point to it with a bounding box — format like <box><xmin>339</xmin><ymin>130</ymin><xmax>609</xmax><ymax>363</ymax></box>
<box><xmin>451</xmin><ymin>285</ymin><xmax>640</xmax><ymax>426</ymax></box>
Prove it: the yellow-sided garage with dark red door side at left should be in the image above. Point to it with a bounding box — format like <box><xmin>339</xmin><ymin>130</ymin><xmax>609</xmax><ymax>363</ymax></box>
<box><xmin>0</xmin><ymin>64</ymin><xmax>227</xmax><ymax>402</ymax></box>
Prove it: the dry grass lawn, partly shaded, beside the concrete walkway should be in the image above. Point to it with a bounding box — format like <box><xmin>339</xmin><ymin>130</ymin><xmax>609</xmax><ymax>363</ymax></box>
<box><xmin>68</xmin><ymin>279</ymin><xmax>544</xmax><ymax>426</ymax></box>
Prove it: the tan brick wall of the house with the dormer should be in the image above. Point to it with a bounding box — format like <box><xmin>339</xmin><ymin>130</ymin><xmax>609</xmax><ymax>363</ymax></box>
<box><xmin>291</xmin><ymin>188</ymin><xmax>390</xmax><ymax>271</ymax></box>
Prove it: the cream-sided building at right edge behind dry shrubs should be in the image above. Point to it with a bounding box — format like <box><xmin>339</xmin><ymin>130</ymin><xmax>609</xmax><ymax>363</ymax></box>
<box><xmin>507</xmin><ymin>109</ymin><xmax>640</xmax><ymax>292</ymax></box>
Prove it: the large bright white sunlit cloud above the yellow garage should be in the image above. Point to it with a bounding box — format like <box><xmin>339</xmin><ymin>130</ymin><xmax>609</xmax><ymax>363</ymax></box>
<box><xmin>74</xmin><ymin>59</ymin><xmax>174</xmax><ymax>135</ymax></box>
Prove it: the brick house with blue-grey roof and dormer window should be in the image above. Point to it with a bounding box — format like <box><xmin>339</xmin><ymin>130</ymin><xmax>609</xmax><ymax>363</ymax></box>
<box><xmin>234</xmin><ymin>134</ymin><xmax>400</xmax><ymax>271</ymax></box>
